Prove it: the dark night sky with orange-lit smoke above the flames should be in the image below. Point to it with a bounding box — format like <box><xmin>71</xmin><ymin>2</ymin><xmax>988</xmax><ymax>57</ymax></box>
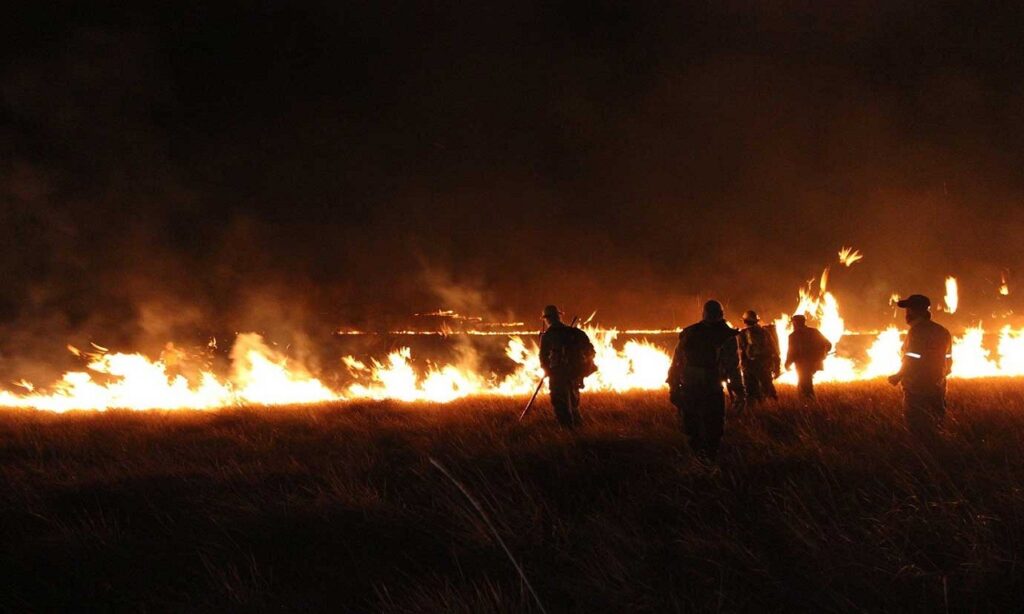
<box><xmin>0</xmin><ymin>1</ymin><xmax>1024</xmax><ymax>355</ymax></box>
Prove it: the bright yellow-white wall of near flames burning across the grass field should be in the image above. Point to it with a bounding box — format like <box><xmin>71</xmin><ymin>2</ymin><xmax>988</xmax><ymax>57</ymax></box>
<box><xmin>0</xmin><ymin>251</ymin><xmax>1024</xmax><ymax>411</ymax></box>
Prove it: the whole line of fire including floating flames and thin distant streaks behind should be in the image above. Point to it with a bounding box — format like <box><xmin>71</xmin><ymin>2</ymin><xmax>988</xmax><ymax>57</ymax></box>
<box><xmin>0</xmin><ymin>248</ymin><xmax>1024</xmax><ymax>411</ymax></box>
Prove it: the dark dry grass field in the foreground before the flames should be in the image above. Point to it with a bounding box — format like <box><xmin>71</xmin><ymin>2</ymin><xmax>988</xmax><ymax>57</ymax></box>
<box><xmin>0</xmin><ymin>380</ymin><xmax>1024</xmax><ymax>612</ymax></box>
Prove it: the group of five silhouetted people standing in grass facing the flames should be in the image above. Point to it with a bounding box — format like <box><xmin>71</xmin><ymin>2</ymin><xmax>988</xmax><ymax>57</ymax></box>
<box><xmin>541</xmin><ymin>295</ymin><xmax>952</xmax><ymax>462</ymax></box>
